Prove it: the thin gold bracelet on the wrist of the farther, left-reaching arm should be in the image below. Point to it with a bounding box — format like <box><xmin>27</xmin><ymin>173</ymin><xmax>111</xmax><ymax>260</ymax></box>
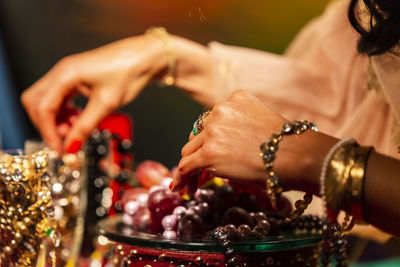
<box><xmin>146</xmin><ymin>27</ymin><xmax>176</xmax><ymax>86</ymax></box>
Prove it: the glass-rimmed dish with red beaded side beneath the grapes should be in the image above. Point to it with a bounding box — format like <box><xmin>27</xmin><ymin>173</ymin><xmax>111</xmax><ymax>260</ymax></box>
<box><xmin>98</xmin><ymin>216</ymin><xmax>322</xmax><ymax>266</ymax></box>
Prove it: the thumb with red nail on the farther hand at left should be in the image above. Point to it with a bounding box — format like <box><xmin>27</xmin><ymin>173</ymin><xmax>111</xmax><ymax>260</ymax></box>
<box><xmin>64</xmin><ymin>90</ymin><xmax>119</xmax><ymax>153</ymax></box>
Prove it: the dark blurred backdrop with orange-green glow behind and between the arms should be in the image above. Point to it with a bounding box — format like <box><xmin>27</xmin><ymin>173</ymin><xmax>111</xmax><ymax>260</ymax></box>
<box><xmin>0</xmin><ymin>0</ymin><xmax>328</xmax><ymax>167</ymax></box>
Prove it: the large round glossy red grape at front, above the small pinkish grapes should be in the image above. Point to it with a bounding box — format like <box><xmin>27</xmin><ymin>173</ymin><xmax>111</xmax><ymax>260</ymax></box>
<box><xmin>147</xmin><ymin>188</ymin><xmax>182</xmax><ymax>220</ymax></box>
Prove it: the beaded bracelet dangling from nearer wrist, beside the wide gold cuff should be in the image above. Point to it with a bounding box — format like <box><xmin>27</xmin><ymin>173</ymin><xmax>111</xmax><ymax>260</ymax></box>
<box><xmin>260</xmin><ymin>120</ymin><xmax>318</xmax><ymax>220</ymax></box>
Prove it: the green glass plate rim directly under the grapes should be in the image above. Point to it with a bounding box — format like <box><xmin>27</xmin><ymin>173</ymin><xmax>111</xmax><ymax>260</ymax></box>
<box><xmin>98</xmin><ymin>216</ymin><xmax>322</xmax><ymax>252</ymax></box>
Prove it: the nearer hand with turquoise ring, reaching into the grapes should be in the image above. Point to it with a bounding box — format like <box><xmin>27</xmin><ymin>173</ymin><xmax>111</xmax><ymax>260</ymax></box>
<box><xmin>172</xmin><ymin>91</ymin><xmax>286</xmax><ymax>194</ymax></box>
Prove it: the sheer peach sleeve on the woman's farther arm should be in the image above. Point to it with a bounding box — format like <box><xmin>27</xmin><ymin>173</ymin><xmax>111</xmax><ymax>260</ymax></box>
<box><xmin>209</xmin><ymin>1</ymin><xmax>397</xmax><ymax>159</ymax></box>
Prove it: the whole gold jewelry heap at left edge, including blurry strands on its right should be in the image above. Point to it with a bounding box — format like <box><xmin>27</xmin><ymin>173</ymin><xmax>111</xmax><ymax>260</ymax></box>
<box><xmin>0</xmin><ymin>151</ymin><xmax>85</xmax><ymax>266</ymax></box>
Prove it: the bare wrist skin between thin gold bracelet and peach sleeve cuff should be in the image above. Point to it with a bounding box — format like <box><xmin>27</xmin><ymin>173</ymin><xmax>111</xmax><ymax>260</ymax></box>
<box><xmin>171</xmin><ymin>36</ymin><xmax>216</xmax><ymax>107</ymax></box>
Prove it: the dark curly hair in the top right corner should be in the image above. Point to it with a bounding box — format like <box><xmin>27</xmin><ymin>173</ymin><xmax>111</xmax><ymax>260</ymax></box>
<box><xmin>348</xmin><ymin>0</ymin><xmax>400</xmax><ymax>56</ymax></box>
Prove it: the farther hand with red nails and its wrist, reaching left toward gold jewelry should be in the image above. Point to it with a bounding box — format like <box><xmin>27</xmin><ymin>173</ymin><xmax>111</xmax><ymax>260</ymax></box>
<box><xmin>22</xmin><ymin>34</ymin><xmax>216</xmax><ymax>153</ymax></box>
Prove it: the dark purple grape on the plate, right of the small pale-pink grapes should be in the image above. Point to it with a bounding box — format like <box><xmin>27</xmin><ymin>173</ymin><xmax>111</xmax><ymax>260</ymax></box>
<box><xmin>178</xmin><ymin>214</ymin><xmax>205</xmax><ymax>240</ymax></box>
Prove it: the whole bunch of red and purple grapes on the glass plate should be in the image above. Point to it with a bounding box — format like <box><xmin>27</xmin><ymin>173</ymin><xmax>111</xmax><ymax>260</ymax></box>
<box><xmin>122</xmin><ymin>161</ymin><xmax>292</xmax><ymax>240</ymax></box>
